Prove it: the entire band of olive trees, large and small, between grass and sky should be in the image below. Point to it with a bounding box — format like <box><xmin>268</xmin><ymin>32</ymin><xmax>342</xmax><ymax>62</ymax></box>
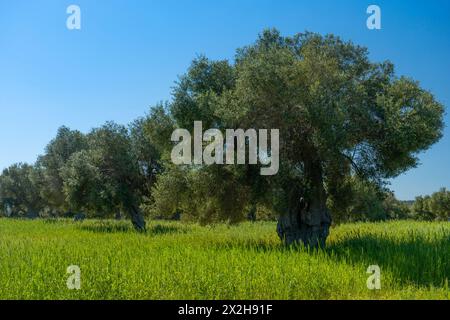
<box><xmin>0</xmin><ymin>30</ymin><xmax>448</xmax><ymax>246</ymax></box>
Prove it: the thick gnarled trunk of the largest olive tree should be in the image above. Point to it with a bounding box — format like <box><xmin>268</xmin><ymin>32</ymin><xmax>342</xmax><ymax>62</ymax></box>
<box><xmin>277</xmin><ymin>161</ymin><xmax>331</xmax><ymax>248</ymax></box>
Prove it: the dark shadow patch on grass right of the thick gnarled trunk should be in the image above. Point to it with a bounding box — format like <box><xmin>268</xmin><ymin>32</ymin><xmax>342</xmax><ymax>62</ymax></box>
<box><xmin>325</xmin><ymin>235</ymin><xmax>450</xmax><ymax>287</ymax></box>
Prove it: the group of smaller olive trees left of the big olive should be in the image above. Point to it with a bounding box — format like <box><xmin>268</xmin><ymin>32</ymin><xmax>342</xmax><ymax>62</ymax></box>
<box><xmin>0</xmin><ymin>118</ymin><xmax>165</xmax><ymax>230</ymax></box>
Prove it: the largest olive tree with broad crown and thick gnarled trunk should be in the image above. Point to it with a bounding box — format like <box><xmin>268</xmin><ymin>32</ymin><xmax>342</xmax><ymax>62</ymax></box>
<box><xmin>150</xmin><ymin>30</ymin><xmax>444</xmax><ymax>246</ymax></box>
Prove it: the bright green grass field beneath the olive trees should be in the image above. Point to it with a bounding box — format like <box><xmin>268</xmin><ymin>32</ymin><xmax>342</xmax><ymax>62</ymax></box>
<box><xmin>0</xmin><ymin>219</ymin><xmax>450</xmax><ymax>299</ymax></box>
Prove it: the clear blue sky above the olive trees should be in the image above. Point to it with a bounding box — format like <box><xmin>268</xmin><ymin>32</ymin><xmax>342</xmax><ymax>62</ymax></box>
<box><xmin>0</xmin><ymin>0</ymin><xmax>450</xmax><ymax>199</ymax></box>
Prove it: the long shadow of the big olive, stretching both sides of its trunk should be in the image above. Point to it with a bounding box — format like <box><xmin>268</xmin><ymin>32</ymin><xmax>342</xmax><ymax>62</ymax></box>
<box><xmin>209</xmin><ymin>231</ymin><xmax>450</xmax><ymax>287</ymax></box>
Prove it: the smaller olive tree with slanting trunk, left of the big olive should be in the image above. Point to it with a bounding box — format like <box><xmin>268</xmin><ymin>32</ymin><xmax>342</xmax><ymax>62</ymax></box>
<box><xmin>61</xmin><ymin>122</ymin><xmax>156</xmax><ymax>231</ymax></box>
